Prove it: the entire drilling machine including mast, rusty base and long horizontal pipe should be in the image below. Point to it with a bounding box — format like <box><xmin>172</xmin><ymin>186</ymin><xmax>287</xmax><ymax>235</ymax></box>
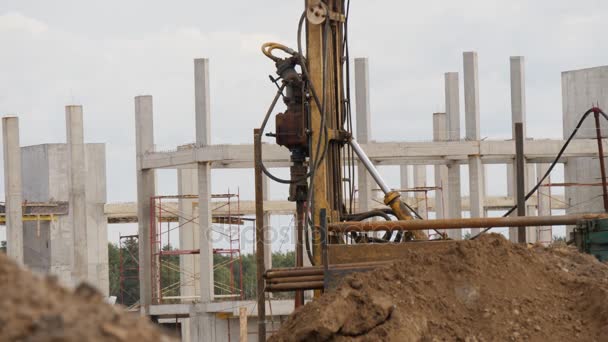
<box><xmin>254</xmin><ymin>0</ymin><xmax>608</xmax><ymax>340</ymax></box>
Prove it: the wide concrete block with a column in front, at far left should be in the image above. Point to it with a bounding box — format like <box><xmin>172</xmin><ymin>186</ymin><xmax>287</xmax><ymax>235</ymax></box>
<box><xmin>5</xmin><ymin>106</ymin><xmax>109</xmax><ymax>296</ymax></box>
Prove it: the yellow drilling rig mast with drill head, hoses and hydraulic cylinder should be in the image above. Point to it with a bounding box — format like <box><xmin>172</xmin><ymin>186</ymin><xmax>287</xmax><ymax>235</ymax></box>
<box><xmin>255</xmin><ymin>0</ymin><xmax>427</xmax><ymax>318</ymax></box>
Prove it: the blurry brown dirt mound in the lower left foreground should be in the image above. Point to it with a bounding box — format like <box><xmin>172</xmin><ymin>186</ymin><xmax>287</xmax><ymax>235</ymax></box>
<box><xmin>0</xmin><ymin>253</ymin><xmax>172</xmax><ymax>341</ymax></box>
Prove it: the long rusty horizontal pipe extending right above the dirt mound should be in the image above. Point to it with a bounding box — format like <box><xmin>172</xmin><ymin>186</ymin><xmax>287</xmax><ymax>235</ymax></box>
<box><xmin>328</xmin><ymin>214</ymin><xmax>608</xmax><ymax>233</ymax></box>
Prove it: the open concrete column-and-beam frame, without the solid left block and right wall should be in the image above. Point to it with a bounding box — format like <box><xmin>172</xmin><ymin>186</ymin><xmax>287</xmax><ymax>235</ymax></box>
<box><xmin>129</xmin><ymin>52</ymin><xmax>608</xmax><ymax>340</ymax></box>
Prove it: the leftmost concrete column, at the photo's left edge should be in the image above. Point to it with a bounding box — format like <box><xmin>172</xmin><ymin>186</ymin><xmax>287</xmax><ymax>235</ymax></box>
<box><xmin>2</xmin><ymin>116</ymin><xmax>23</xmax><ymax>265</ymax></box>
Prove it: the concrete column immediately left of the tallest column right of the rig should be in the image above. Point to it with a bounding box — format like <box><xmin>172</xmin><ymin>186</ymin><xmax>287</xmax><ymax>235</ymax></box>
<box><xmin>445</xmin><ymin>72</ymin><xmax>462</xmax><ymax>240</ymax></box>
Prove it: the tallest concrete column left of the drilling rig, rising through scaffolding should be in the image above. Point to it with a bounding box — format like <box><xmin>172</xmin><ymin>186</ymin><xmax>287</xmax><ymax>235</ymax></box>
<box><xmin>194</xmin><ymin>58</ymin><xmax>214</xmax><ymax>303</ymax></box>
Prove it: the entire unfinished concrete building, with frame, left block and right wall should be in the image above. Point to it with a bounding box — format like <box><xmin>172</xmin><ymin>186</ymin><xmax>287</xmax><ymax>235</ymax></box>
<box><xmin>3</xmin><ymin>52</ymin><xmax>608</xmax><ymax>341</ymax></box>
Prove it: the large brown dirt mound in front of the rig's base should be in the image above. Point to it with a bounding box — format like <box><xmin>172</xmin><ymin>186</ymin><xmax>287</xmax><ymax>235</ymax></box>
<box><xmin>271</xmin><ymin>234</ymin><xmax>608</xmax><ymax>342</ymax></box>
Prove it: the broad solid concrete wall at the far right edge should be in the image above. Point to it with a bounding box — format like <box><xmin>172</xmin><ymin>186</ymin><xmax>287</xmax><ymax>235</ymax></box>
<box><xmin>562</xmin><ymin>66</ymin><xmax>608</xmax><ymax>235</ymax></box>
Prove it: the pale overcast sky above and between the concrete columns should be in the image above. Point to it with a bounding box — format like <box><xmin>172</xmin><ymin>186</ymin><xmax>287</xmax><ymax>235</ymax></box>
<box><xmin>0</xmin><ymin>0</ymin><xmax>608</xmax><ymax>246</ymax></box>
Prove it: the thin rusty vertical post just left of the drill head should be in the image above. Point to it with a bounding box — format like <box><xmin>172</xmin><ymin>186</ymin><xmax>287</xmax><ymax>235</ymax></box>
<box><xmin>253</xmin><ymin>128</ymin><xmax>266</xmax><ymax>341</ymax></box>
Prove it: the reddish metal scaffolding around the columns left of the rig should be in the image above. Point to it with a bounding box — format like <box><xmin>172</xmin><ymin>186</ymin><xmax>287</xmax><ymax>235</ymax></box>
<box><xmin>150</xmin><ymin>191</ymin><xmax>244</xmax><ymax>304</ymax></box>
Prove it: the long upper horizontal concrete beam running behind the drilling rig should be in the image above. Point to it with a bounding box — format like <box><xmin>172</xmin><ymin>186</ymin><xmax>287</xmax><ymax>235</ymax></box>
<box><xmin>143</xmin><ymin>139</ymin><xmax>608</xmax><ymax>169</ymax></box>
